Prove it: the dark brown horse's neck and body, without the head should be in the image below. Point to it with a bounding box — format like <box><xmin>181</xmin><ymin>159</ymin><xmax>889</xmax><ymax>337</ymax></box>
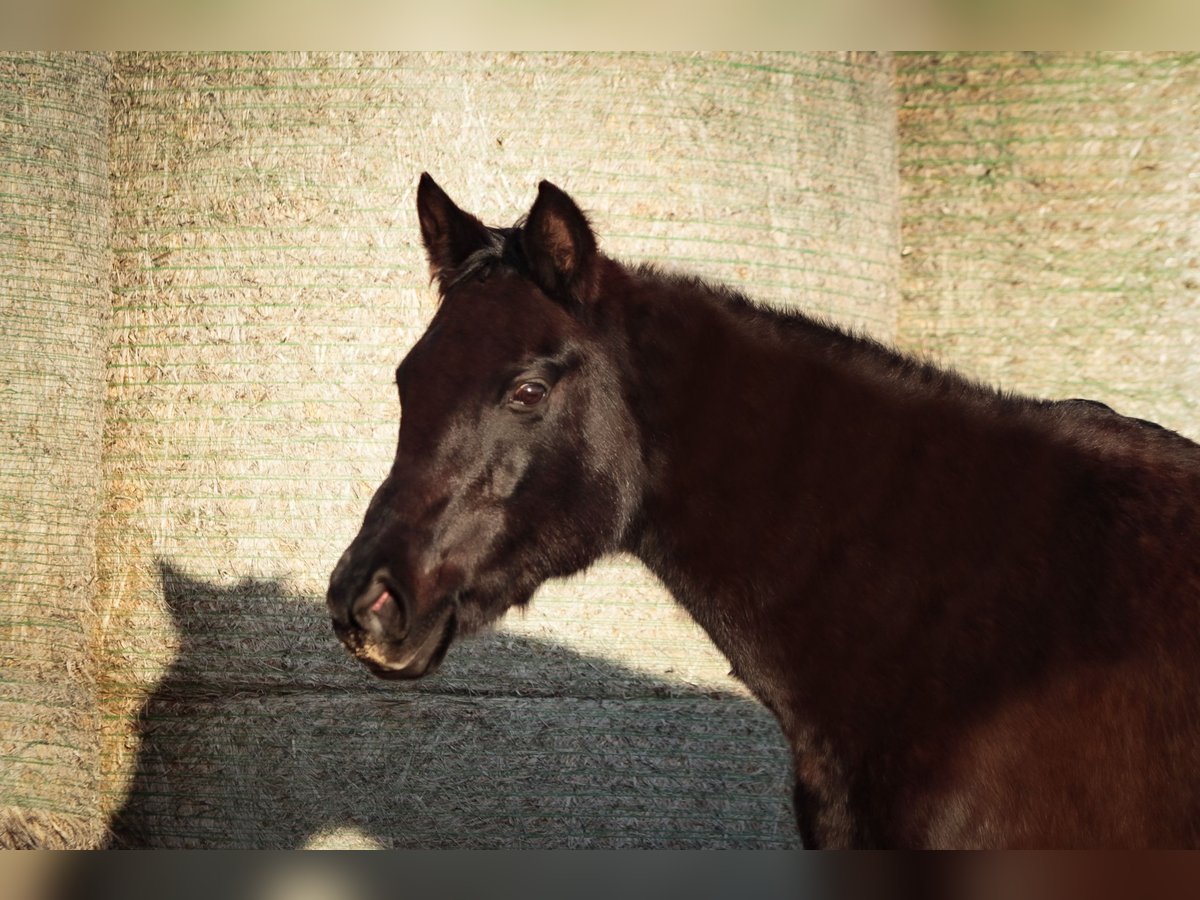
<box><xmin>609</xmin><ymin>262</ymin><xmax>1200</xmax><ymax>846</ymax></box>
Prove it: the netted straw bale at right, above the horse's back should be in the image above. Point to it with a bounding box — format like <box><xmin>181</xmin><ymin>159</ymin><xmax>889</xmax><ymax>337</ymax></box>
<box><xmin>898</xmin><ymin>53</ymin><xmax>1200</xmax><ymax>438</ymax></box>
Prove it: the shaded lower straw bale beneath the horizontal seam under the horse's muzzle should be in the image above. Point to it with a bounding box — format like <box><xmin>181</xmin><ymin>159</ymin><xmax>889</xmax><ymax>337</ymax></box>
<box><xmin>105</xmin><ymin>691</ymin><xmax>794</xmax><ymax>848</ymax></box>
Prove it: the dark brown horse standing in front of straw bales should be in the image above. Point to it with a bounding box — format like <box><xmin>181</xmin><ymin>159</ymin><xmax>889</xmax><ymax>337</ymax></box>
<box><xmin>328</xmin><ymin>174</ymin><xmax>1200</xmax><ymax>848</ymax></box>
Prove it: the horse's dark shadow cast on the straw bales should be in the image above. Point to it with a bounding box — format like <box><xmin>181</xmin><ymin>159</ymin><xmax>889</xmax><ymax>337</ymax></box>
<box><xmin>103</xmin><ymin>564</ymin><xmax>798</xmax><ymax>848</ymax></box>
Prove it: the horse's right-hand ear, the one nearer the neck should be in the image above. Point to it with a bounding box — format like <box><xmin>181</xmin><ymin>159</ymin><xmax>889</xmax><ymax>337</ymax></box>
<box><xmin>522</xmin><ymin>181</ymin><xmax>596</xmax><ymax>304</ymax></box>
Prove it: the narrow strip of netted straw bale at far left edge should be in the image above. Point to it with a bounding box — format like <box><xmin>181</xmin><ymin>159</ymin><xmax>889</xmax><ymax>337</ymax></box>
<box><xmin>0</xmin><ymin>54</ymin><xmax>110</xmax><ymax>847</ymax></box>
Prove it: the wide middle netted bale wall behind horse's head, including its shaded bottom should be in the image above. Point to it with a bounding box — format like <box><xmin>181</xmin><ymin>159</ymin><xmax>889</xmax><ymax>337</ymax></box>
<box><xmin>101</xmin><ymin>53</ymin><xmax>898</xmax><ymax>847</ymax></box>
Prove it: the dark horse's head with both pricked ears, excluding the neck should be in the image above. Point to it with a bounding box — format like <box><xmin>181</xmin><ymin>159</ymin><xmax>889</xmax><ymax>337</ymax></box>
<box><xmin>328</xmin><ymin>175</ymin><xmax>641</xmax><ymax>678</ymax></box>
